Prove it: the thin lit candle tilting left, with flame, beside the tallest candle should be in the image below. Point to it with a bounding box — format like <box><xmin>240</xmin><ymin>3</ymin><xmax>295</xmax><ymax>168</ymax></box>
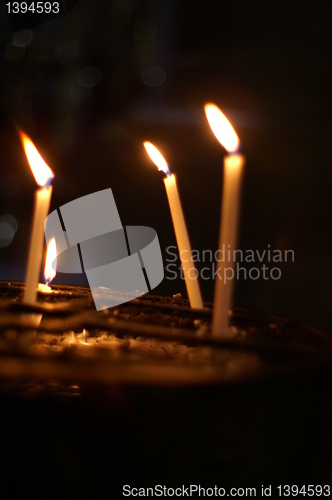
<box><xmin>144</xmin><ymin>142</ymin><xmax>203</xmax><ymax>309</ymax></box>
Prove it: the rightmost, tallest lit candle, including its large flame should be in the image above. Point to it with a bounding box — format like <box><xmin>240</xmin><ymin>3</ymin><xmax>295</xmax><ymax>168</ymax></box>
<box><xmin>204</xmin><ymin>104</ymin><xmax>245</xmax><ymax>336</ymax></box>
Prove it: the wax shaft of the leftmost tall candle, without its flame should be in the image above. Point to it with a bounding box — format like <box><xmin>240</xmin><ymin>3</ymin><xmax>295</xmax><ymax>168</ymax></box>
<box><xmin>23</xmin><ymin>186</ymin><xmax>52</xmax><ymax>303</ymax></box>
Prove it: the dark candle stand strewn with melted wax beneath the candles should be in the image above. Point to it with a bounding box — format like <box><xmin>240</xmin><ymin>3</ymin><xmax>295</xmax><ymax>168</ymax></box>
<box><xmin>0</xmin><ymin>282</ymin><xmax>332</xmax><ymax>496</ymax></box>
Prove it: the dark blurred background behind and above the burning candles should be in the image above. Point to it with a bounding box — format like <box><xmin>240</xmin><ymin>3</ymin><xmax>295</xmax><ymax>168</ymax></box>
<box><xmin>0</xmin><ymin>0</ymin><xmax>332</xmax><ymax>328</ymax></box>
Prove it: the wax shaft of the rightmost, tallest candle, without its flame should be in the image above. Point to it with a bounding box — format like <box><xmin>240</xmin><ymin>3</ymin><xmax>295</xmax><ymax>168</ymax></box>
<box><xmin>212</xmin><ymin>154</ymin><xmax>245</xmax><ymax>337</ymax></box>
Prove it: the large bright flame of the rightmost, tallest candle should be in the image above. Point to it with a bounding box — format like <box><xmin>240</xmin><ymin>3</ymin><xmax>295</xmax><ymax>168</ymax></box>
<box><xmin>204</xmin><ymin>103</ymin><xmax>240</xmax><ymax>153</ymax></box>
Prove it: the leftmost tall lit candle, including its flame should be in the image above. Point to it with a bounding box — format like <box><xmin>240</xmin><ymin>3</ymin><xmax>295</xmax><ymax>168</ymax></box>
<box><xmin>20</xmin><ymin>131</ymin><xmax>54</xmax><ymax>303</ymax></box>
